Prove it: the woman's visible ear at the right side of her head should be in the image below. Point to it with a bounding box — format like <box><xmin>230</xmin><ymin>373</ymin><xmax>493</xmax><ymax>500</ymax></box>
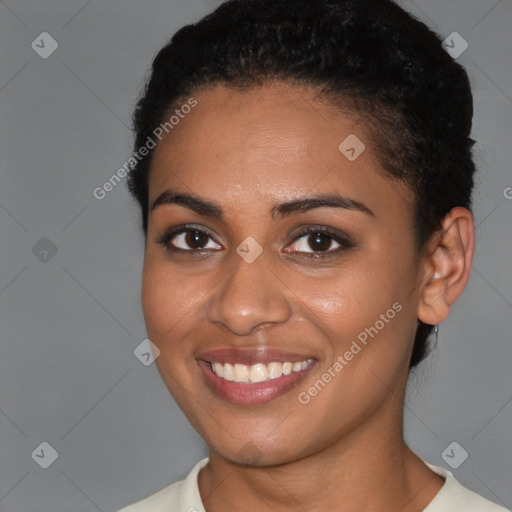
<box><xmin>418</xmin><ymin>207</ymin><xmax>475</xmax><ymax>325</ymax></box>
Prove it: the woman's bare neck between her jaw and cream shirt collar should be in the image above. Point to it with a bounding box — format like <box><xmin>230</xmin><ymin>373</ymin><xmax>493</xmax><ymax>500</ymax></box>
<box><xmin>199</xmin><ymin>402</ymin><xmax>444</xmax><ymax>512</ymax></box>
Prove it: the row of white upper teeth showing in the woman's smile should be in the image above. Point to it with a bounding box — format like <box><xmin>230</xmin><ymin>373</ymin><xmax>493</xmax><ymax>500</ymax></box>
<box><xmin>212</xmin><ymin>359</ymin><xmax>313</xmax><ymax>383</ymax></box>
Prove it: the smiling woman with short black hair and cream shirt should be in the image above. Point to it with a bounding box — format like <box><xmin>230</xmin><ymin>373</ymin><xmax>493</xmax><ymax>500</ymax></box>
<box><xmin>119</xmin><ymin>0</ymin><xmax>505</xmax><ymax>512</ymax></box>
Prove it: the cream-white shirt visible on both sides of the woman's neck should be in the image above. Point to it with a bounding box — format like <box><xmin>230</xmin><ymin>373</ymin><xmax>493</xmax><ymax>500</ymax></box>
<box><xmin>119</xmin><ymin>458</ymin><xmax>508</xmax><ymax>512</ymax></box>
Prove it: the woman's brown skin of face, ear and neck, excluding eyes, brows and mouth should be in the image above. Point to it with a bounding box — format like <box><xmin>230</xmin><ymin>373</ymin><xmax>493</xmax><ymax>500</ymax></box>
<box><xmin>142</xmin><ymin>84</ymin><xmax>474</xmax><ymax>512</ymax></box>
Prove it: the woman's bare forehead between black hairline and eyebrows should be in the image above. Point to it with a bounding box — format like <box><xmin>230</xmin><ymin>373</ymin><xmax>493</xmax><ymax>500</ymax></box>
<box><xmin>150</xmin><ymin>84</ymin><xmax>409</xmax><ymax>218</ymax></box>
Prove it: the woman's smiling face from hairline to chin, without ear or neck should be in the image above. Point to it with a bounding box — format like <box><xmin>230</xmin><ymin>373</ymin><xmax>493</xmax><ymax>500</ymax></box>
<box><xmin>142</xmin><ymin>84</ymin><xmax>422</xmax><ymax>464</ymax></box>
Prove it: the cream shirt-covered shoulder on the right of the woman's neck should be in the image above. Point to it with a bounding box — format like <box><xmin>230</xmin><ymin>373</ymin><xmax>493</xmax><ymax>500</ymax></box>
<box><xmin>424</xmin><ymin>461</ymin><xmax>508</xmax><ymax>512</ymax></box>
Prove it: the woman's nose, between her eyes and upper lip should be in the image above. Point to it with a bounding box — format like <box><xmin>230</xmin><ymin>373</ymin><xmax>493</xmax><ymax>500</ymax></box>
<box><xmin>207</xmin><ymin>254</ymin><xmax>291</xmax><ymax>336</ymax></box>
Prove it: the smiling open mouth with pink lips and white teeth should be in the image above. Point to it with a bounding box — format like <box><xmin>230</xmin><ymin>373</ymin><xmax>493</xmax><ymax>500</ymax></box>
<box><xmin>198</xmin><ymin>349</ymin><xmax>317</xmax><ymax>405</ymax></box>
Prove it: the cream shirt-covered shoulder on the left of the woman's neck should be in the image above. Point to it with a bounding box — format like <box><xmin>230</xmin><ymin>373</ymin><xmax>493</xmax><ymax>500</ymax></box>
<box><xmin>118</xmin><ymin>459</ymin><xmax>208</xmax><ymax>512</ymax></box>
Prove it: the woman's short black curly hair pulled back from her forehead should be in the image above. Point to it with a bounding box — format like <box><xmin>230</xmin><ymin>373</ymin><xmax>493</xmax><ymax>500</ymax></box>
<box><xmin>128</xmin><ymin>0</ymin><xmax>475</xmax><ymax>368</ymax></box>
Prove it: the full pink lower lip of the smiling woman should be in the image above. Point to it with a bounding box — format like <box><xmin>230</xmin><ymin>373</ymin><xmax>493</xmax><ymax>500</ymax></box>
<box><xmin>198</xmin><ymin>361</ymin><xmax>315</xmax><ymax>405</ymax></box>
